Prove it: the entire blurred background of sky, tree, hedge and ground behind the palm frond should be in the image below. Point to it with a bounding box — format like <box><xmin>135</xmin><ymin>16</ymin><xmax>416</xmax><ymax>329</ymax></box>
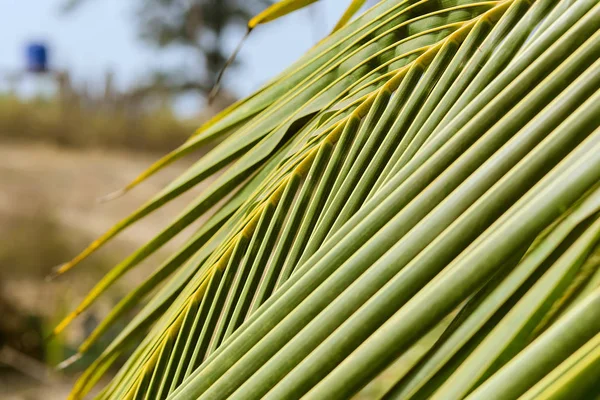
<box><xmin>0</xmin><ymin>0</ymin><xmax>360</xmax><ymax>400</ymax></box>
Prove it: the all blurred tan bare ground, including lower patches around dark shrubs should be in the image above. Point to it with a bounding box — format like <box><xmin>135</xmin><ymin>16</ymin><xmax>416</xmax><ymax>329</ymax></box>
<box><xmin>0</xmin><ymin>142</ymin><xmax>216</xmax><ymax>400</ymax></box>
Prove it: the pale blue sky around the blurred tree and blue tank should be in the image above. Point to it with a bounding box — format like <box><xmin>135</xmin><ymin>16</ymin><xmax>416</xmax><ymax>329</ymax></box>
<box><xmin>0</xmin><ymin>0</ymin><xmax>348</xmax><ymax>112</ymax></box>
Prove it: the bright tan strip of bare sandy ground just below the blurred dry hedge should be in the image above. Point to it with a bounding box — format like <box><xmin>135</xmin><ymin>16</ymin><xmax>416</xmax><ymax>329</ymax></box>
<box><xmin>0</xmin><ymin>143</ymin><xmax>211</xmax><ymax>245</ymax></box>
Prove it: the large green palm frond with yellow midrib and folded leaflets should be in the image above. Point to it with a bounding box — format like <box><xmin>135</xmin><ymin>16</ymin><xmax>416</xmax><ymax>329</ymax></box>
<box><xmin>56</xmin><ymin>0</ymin><xmax>600</xmax><ymax>400</ymax></box>
